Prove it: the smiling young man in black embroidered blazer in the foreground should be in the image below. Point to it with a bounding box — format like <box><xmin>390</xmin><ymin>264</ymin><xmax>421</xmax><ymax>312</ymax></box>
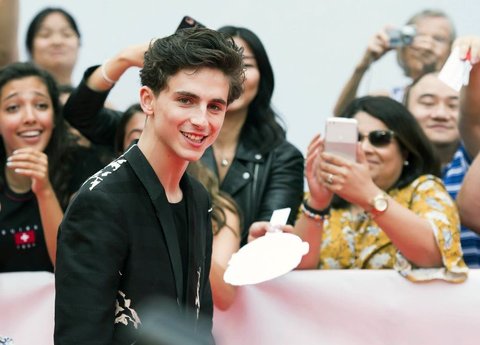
<box><xmin>54</xmin><ymin>28</ymin><xmax>244</xmax><ymax>344</ymax></box>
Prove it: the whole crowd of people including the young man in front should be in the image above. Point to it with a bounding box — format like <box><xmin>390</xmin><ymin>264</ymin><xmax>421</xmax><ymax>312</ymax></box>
<box><xmin>0</xmin><ymin>1</ymin><xmax>480</xmax><ymax>344</ymax></box>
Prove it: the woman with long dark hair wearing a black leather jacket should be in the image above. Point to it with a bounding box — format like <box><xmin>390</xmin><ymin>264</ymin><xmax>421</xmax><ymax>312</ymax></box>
<box><xmin>202</xmin><ymin>26</ymin><xmax>303</xmax><ymax>244</ymax></box>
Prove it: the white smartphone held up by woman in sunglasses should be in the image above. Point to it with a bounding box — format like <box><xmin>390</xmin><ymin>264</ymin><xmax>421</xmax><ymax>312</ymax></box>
<box><xmin>325</xmin><ymin>117</ymin><xmax>358</xmax><ymax>162</ymax></box>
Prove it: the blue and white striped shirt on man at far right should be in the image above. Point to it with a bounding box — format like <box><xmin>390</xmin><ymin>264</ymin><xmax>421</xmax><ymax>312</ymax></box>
<box><xmin>442</xmin><ymin>145</ymin><xmax>480</xmax><ymax>268</ymax></box>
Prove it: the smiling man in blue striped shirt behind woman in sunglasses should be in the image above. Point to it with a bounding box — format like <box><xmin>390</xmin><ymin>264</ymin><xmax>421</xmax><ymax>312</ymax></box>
<box><xmin>405</xmin><ymin>72</ymin><xmax>480</xmax><ymax>268</ymax></box>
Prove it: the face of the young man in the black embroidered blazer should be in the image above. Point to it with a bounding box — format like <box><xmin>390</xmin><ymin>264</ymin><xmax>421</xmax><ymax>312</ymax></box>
<box><xmin>140</xmin><ymin>67</ymin><xmax>230</xmax><ymax>161</ymax></box>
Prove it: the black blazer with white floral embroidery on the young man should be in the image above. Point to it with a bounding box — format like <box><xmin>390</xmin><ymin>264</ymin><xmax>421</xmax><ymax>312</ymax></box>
<box><xmin>54</xmin><ymin>145</ymin><xmax>213</xmax><ymax>345</ymax></box>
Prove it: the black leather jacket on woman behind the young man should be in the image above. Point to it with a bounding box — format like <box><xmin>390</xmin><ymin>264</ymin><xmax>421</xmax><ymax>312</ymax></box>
<box><xmin>202</xmin><ymin>140</ymin><xmax>304</xmax><ymax>245</ymax></box>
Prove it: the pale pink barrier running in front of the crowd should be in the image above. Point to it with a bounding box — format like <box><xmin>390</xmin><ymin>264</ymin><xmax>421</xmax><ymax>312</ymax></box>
<box><xmin>0</xmin><ymin>270</ymin><xmax>480</xmax><ymax>345</ymax></box>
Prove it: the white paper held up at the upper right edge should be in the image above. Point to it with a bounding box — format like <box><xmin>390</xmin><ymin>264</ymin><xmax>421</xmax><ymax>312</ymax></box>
<box><xmin>438</xmin><ymin>47</ymin><xmax>472</xmax><ymax>91</ymax></box>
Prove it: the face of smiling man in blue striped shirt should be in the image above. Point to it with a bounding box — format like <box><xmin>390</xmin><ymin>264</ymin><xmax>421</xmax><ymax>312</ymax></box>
<box><xmin>407</xmin><ymin>74</ymin><xmax>460</xmax><ymax>146</ymax></box>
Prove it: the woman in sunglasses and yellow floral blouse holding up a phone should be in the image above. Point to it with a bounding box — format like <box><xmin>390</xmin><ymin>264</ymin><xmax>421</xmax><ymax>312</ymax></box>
<box><xmin>250</xmin><ymin>96</ymin><xmax>468</xmax><ymax>282</ymax></box>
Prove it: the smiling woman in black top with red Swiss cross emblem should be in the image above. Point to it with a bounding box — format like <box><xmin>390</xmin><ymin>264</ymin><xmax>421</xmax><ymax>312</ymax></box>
<box><xmin>0</xmin><ymin>63</ymin><xmax>104</xmax><ymax>272</ymax></box>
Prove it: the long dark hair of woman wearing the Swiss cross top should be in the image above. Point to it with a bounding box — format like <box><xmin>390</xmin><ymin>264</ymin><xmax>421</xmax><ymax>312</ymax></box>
<box><xmin>0</xmin><ymin>62</ymin><xmax>78</xmax><ymax>209</ymax></box>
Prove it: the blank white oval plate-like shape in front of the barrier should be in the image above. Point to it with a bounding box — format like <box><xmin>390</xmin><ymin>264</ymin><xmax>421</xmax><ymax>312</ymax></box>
<box><xmin>223</xmin><ymin>232</ymin><xmax>308</xmax><ymax>285</ymax></box>
